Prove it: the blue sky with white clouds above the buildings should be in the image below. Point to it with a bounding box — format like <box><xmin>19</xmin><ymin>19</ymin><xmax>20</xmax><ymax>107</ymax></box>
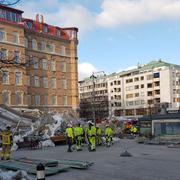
<box><xmin>14</xmin><ymin>0</ymin><xmax>180</xmax><ymax>78</ymax></box>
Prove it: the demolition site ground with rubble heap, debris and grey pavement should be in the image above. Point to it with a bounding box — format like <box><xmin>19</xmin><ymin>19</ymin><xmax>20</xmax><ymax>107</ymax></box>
<box><xmin>0</xmin><ymin>105</ymin><xmax>180</xmax><ymax>180</ymax></box>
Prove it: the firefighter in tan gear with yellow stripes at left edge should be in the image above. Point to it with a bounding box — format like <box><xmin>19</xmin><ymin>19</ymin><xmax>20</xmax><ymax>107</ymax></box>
<box><xmin>0</xmin><ymin>126</ymin><xmax>13</xmax><ymax>160</ymax></box>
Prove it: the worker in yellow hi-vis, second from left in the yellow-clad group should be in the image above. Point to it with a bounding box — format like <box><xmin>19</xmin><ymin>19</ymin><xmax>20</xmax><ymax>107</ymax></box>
<box><xmin>74</xmin><ymin>122</ymin><xmax>84</xmax><ymax>151</ymax></box>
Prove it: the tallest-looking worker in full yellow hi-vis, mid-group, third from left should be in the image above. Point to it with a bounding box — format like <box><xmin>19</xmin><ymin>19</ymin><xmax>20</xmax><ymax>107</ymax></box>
<box><xmin>87</xmin><ymin>121</ymin><xmax>96</xmax><ymax>151</ymax></box>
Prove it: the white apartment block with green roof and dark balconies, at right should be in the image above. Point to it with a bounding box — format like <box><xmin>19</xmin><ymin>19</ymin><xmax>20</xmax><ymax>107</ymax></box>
<box><xmin>80</xmin><ymin>60</ymin><xmax>180</xmax><ymax>117</ymax></box>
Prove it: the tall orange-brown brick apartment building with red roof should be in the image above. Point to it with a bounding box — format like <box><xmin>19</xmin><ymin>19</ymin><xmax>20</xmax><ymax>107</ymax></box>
<box><xmin>0</xmin><ymin>5</ymin><xmax>79</xmax><ymax>112</ymax></box>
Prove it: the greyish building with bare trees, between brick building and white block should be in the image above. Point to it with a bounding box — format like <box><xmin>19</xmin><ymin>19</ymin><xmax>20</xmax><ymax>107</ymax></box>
<box><xmin>79</xmin><ymin>75</ymin><xmax>109</xmax><ymax>120</ymax></box>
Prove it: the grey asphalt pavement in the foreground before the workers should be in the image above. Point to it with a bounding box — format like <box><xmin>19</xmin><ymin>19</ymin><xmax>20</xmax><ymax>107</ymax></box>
<box><xmin>14</xmin><ymin>139</ymin><xmax>180</xmax><ymax>180</ymax></box>
